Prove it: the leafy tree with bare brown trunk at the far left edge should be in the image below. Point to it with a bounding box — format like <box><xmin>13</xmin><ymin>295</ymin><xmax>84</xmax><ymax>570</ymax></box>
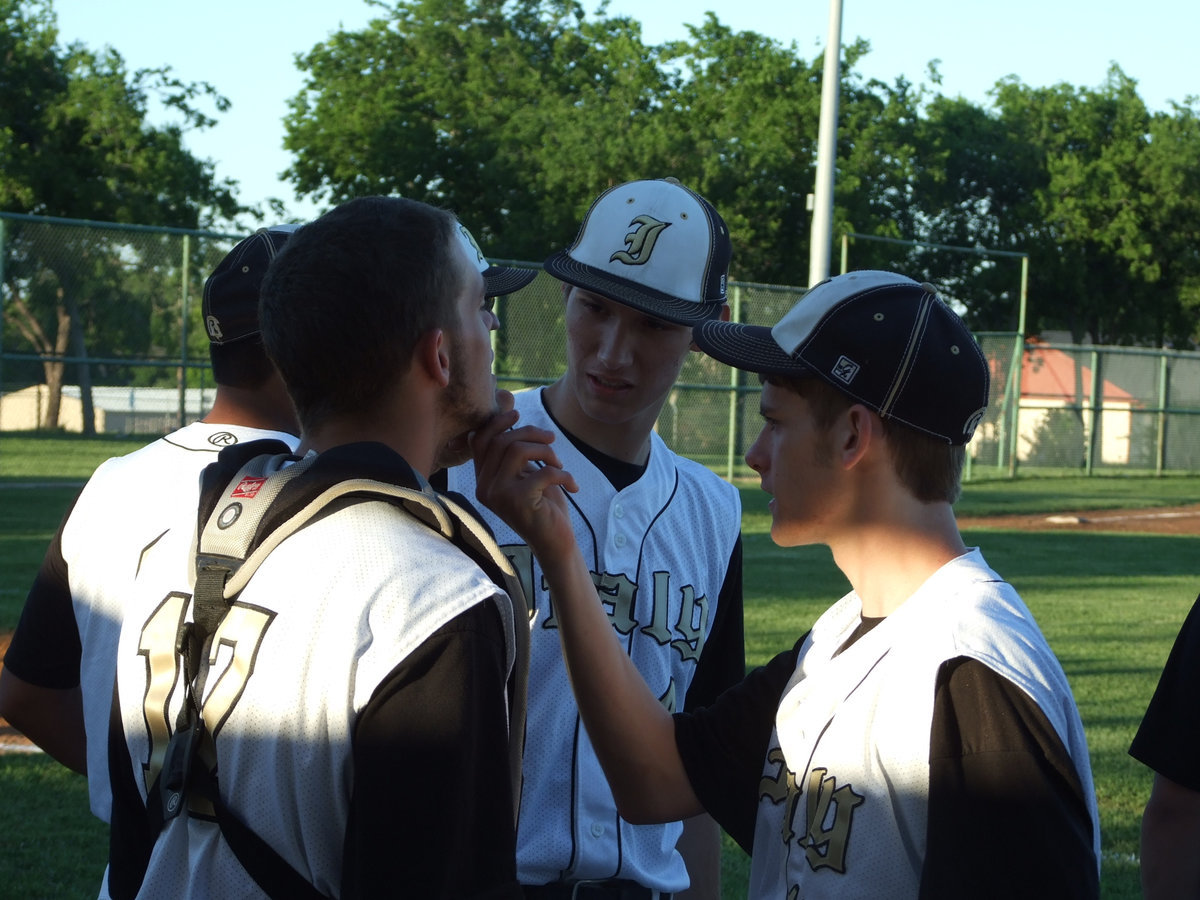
<box><xmin>0</xmin><ymin>0</ymin><xmax>246</xmax><ymax>431</ymax></box>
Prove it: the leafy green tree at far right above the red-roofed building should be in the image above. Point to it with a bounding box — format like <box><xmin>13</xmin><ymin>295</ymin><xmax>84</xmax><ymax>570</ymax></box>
<box><xmin>918</xmin><ymin>66</ymin><xmax>1200</xmax><ymax>344</ymax></box>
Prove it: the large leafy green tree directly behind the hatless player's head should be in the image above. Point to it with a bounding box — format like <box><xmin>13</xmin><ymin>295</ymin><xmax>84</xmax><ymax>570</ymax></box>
<box><xmin>284</xmin><ymin>0</ymin><xmax>665</xmax><ymax>259</ymax></box>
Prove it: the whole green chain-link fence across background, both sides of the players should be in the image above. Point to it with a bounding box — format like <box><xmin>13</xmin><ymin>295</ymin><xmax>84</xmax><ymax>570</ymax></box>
<box><xmin>0</xmin><ymin>214</ymin><xmax>1200</xmax><ymax>478</ymax></box>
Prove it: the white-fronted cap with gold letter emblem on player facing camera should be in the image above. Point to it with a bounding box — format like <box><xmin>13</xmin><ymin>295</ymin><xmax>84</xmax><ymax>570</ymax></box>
<box><xmin>545</xmin><ymin>179</ymin><xmax>733</xmax><ymax>325</ymax></box>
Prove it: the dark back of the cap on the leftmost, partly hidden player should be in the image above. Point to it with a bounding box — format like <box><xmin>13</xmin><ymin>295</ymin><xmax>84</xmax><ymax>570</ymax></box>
<box><xmin>202</xmin><ymin>224</ymin><xmax>300</xmax><ymax>344</ymax></box>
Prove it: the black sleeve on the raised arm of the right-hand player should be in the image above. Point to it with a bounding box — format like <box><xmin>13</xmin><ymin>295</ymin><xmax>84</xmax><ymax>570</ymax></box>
<box><xmin>674</xmin><ymin>638</ymin><xmax>804</xmax><ymax>853</ymax></box>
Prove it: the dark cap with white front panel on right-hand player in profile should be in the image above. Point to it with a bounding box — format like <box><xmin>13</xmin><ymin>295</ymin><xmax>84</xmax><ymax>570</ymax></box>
<box><xmin>692</xmin><ymin>271</ymin><xmax>990</xmax><ymax>444</ymax></box>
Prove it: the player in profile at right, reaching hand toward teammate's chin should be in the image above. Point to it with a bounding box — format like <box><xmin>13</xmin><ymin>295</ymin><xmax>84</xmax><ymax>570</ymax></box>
<box><xmin>475</xmin><ymin>271</ymin><xmax>1099</xmax><ymax>898</ymax></box>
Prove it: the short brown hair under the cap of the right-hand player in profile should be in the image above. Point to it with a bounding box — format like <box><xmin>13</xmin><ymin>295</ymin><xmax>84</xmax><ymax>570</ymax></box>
<box><xmin>762</xmin><ymin>376</ymin><xmax>966</xmax><ymax>503</ymax></box>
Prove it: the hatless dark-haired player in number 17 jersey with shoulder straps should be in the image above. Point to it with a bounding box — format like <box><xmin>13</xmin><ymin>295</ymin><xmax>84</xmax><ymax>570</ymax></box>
<box><xmin>104</xmin><ymin>197</ymin><xmax>528</xmax><ymax>900</ymax></box>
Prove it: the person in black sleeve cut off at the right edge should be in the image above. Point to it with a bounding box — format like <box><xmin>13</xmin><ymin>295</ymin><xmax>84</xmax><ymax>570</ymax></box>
<box><xmin>1129</xmin><ymin>598</ymin><xmax>1200</xmax><ymax>900</ymax></box>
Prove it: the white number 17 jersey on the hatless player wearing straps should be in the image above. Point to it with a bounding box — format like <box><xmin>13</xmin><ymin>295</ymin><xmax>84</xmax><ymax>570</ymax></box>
<box><xmin>102</xmin><ymin>445</ymin><xmax>523</xmax><ymax>900</ymax></box>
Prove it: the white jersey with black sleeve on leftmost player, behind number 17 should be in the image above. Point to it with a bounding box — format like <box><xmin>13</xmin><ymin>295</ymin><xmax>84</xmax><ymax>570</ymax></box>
<box><xmin>8</xmin><ymin>422</ymin><xmax>298</xmax><ymax>822</ymax></box>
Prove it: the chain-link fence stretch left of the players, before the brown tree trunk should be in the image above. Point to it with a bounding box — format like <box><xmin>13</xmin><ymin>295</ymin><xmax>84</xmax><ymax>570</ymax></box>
<box><xmin>0</xmin><ymin>214</ymin><xmax>242</xmax><ymax>434</ymax></box>
